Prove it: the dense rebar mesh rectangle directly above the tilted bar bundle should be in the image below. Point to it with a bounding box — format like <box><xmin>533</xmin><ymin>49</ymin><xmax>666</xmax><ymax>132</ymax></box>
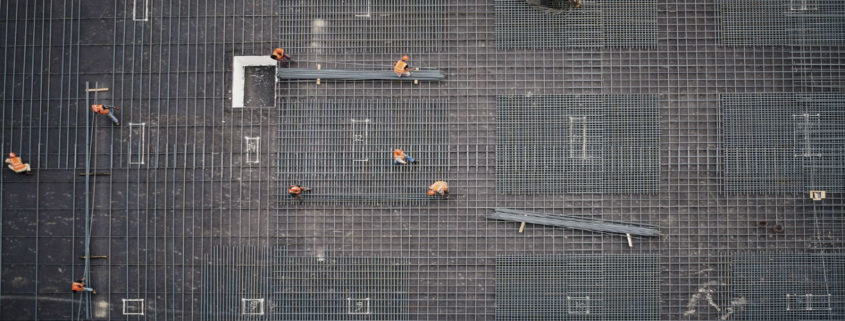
<box><xmin>496</xmin><ymin>95</ymin><xmax>660</xmax><ymax>194</ymax></box>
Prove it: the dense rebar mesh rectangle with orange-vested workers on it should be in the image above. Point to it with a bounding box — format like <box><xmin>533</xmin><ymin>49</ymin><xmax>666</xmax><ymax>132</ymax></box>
<box><xmin>278</xmin><ymin>100</ymin><xmax>450</xmax><ymax>202</ymax></box>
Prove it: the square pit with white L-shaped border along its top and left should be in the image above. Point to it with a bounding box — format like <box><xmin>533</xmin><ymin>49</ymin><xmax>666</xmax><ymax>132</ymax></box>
<box><xmin>232</xmin><ymin>55</ymin><xmax>276</xmax><ymax>108</ymax></box>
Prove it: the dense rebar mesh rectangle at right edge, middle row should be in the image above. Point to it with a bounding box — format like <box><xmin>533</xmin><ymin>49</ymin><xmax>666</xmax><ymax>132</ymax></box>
<box><xmin>722</xmin><ymin>93</ymin><xmax>845</xmax><ymax>193</ymax></box>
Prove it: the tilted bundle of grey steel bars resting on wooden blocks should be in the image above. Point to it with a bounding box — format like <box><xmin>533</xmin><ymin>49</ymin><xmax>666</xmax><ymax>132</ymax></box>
<box><xmin>487</xmin><ymin>208</ymin><xmax>660</xmax><ymax>236</ymax></box>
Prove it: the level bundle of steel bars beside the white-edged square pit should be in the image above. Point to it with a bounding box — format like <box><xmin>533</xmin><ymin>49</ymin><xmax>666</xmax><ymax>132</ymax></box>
<box><xmin>276</xmin><ymin>68</ymin><xmax>446</xmax><ymax>81</ymax></box>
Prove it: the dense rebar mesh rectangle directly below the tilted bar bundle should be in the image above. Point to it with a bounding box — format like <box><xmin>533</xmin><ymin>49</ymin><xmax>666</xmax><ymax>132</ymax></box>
<box><xmin>496</xmin><ymin>255</ymin><xmax>660</xmax><ymax>320</ymax></box>
